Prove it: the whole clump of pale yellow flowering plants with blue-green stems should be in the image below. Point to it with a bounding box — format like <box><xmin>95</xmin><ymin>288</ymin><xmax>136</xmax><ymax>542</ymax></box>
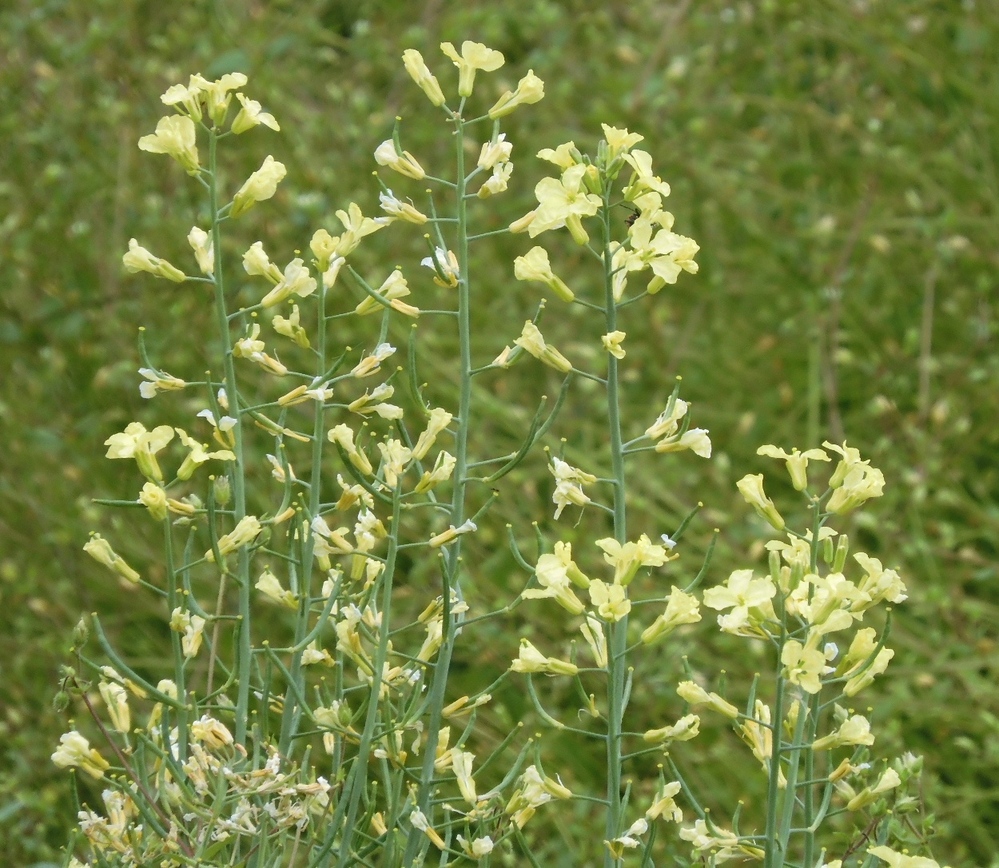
<box><xmin>53</xmin><ymin>42</ymin><xmax>948</xmax><ymax>866</ymax></box>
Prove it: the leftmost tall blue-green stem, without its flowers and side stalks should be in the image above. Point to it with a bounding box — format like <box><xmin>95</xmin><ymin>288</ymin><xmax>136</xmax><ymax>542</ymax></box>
<box><xmin>208</xmin><ymin>129</ymin><xmax>253</xmax><ymax>747</ymax></box>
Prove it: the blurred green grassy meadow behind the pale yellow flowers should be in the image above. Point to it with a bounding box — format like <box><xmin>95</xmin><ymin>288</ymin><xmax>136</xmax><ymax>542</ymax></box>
<box><xmin>0</xmin><ymin>0</ymin><xmax>999</xmax><ymax>866</ymax></box>
